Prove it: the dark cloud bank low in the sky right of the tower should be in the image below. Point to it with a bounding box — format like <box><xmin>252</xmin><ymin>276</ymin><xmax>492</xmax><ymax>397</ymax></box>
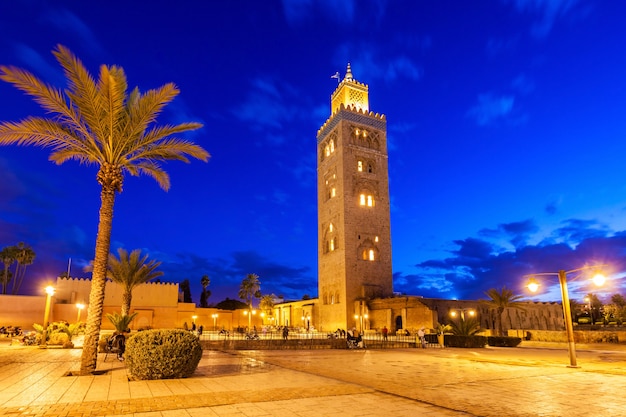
<box><xmin>394</xmin><ymin>219</ymin><xmax>626</xmax><ymax>301</ymax></box>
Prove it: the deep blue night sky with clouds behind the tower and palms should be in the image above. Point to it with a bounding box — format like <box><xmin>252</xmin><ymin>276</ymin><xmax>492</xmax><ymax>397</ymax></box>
<box><xmin>0</xmin><ymin>0</ymin><xmax>626</xmax><ymax>303</ymax></box>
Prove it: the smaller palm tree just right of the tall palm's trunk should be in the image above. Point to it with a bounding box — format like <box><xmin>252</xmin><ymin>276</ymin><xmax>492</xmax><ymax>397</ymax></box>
<box><xmin>107</xmin><ymin>248</ymin><xmax>163</xmax><ymax>316</ymax></box>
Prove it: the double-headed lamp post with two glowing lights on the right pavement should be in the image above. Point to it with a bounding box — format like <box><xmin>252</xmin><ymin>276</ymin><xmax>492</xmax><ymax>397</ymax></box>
<box><xmin>527</xmin><ymin>265</ymin><xmax>606</xmax><ymax>368</ymax></box>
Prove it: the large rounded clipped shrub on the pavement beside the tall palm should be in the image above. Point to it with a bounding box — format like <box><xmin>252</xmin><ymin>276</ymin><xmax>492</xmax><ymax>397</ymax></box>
<box><xmin>125</xmin><ymin>330</ymin><xmax>202</xmax><ymax>379</ymax></box>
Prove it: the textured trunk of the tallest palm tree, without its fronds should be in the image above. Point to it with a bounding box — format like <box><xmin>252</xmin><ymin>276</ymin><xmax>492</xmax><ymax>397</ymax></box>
<box><xmin>80</xmin><ymin>185</ymin><xmax>115</xmax><ymax>375</ymax></box>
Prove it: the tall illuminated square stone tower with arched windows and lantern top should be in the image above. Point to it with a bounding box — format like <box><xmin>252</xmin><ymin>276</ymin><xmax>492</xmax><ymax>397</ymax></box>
<box><xmin>317</xmin><ymin>64</ymin><xmax>393</xmax><ymax>330</ymax></box>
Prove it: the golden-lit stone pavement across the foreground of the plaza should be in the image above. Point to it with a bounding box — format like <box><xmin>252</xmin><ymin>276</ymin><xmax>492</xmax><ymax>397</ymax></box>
<box><xmin>0</xmin><ymin>342</ymin><xmax>626</xmax><ymax>417</ymax></box>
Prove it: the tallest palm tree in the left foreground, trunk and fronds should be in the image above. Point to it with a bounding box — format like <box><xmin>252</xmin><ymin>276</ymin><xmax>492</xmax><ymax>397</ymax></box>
<box><xmin>0</xmin><ymin>45</ymin><xmax>209</xmax><ymax>375</ymax></box>
